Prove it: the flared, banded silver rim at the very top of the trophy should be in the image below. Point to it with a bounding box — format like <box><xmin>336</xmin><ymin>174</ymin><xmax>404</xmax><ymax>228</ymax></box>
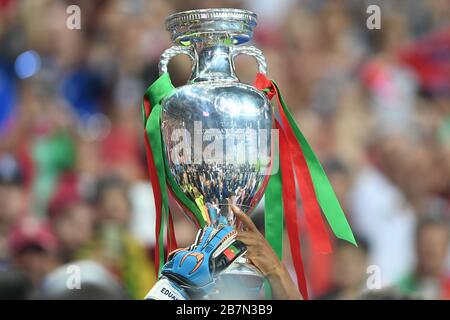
<box><xmin>166</xmin><ymin>8</ymin><xmax>257</xmax><ymax>45</ymax></box>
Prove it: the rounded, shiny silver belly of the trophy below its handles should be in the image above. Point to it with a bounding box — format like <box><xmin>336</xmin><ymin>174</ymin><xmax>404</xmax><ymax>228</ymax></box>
<box><xmin>162</xmin><ymin>81</ymin><xmax>272</xmax><ymax>224</ymax></box>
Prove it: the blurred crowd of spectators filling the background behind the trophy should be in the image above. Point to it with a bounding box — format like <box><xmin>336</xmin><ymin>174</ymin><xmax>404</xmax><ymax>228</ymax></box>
<box><xmin>0</xmin><ymin>0</ymin><xmax>450</xmax><ymax>299</ymax></box>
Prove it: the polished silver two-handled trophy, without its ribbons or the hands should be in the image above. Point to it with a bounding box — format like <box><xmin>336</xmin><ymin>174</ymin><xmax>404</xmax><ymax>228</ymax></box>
<box><xmin>159</xmin><ymin>9</ymin><xmax>273</xmax><ymax>298</ymax></box>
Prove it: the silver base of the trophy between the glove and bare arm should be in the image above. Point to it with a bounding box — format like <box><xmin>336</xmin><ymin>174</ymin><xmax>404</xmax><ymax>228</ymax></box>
<box><xmin>208</xmin><ymin>257</ymin><xmax>264</xmax><ymax>300</ymax></box>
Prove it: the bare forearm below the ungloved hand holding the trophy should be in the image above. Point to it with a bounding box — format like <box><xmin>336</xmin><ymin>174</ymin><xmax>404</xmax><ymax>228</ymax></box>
<box><xmin>266</xmin><ymin>262</ymin><xmax>303</xmax><ymax>300</ymax></box>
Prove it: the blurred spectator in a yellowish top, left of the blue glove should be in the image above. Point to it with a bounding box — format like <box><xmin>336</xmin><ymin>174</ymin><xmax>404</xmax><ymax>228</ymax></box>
<box><xmin>77</xmin><ymin>176</ymin><xmax>155</xmax><ymax>299</ymax></box>
